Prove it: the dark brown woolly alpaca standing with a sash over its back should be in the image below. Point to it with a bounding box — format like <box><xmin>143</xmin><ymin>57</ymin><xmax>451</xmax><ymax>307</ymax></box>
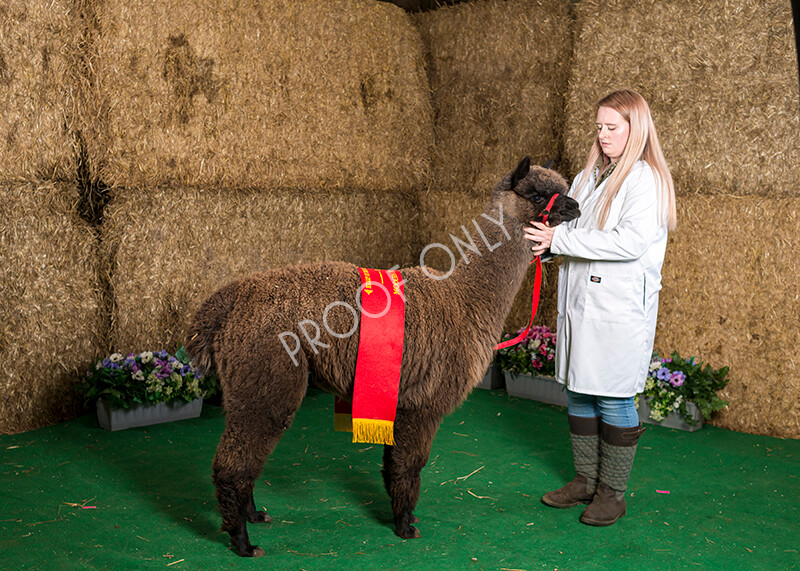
<box><xmin>187</xmin><ymin>157</ymin><xmax>580</xmax><ymax>556</ymax></box>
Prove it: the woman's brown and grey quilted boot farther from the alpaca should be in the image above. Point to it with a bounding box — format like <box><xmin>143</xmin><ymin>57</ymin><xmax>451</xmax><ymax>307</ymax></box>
<box><xmin>581</xmin><ymin>422</ymin><xmax>645</xmax><ymax>525</ymax></box>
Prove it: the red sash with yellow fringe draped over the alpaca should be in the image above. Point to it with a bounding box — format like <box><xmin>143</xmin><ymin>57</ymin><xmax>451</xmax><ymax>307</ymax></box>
<box><xmin>334</xmin><ymin>268</ymin><xmax>405</xmax><ymax>444</ymax></box>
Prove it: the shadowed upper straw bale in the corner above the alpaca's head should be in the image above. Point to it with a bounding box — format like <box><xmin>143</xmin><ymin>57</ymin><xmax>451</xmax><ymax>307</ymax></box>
<box><xmin>415</xmin><ymin>0</ymin><xmax>572</xmax><ymax>196</ymax></box>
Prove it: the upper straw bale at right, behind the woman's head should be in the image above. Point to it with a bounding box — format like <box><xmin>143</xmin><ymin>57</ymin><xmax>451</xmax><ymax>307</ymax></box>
<box><xmin>565</xmin><ymin>0</ymin><xmax>800</xmax><ymax>196</ymax></box>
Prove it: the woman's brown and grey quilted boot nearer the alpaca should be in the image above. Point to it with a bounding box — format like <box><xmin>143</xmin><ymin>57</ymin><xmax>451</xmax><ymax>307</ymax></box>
<box><xmin>542</xmin><ymin>416</ymin><xmax>600</xmax><ymax>508</ymax></box>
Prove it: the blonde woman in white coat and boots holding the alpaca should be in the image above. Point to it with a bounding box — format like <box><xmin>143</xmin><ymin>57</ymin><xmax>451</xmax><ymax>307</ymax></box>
<box><xmin>525</xmin><ymin>90</ymin><xmax>676</xmax><ymax>525</ymax></box>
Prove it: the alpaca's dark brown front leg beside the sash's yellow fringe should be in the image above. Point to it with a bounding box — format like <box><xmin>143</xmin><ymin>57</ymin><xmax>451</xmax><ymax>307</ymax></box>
<box><xmin>384</xmin><ymin>411</ymin><xmax>438</xmax><ymax>539</ymax></box>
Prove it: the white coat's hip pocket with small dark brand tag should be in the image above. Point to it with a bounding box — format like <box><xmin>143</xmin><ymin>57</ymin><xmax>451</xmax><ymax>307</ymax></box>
<box><xmin>584</xmin><ymin>271</ymin><xmax>644</xmax><ymax>323</ymax></box>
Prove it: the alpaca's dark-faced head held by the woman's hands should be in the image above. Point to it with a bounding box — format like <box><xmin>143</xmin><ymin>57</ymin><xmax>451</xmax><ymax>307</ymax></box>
<box><xmin>495</xmin><ymin>157</ymin><xmax>581</xmax><ymax>226</ymax></box>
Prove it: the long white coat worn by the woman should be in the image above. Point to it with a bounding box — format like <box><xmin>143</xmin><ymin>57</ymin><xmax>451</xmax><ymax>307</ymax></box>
<box><xmin>550</xmin><ymin>161</ymin><xmax>667</xmax><ymax>397</ymax></box>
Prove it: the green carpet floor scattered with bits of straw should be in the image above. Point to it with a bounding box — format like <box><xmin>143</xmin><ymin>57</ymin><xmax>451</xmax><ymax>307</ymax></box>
<box><xmin>0</xmin><ymin>389</ymin><xmax>800</xmax><ymax>570</ymax></box>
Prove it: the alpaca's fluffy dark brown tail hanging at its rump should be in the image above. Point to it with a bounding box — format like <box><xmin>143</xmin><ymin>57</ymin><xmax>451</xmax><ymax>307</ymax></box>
<box><xmin>186</xmin><ymin>284</ymin><xmax>235</xmax><ymax>373</ymax></box>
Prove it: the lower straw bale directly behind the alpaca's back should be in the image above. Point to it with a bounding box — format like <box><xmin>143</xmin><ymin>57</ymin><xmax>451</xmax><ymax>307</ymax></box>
<box><xmin>103</xmin><ymin>188</ymin><xmax>419</xmax><ymax>352</ymax></box>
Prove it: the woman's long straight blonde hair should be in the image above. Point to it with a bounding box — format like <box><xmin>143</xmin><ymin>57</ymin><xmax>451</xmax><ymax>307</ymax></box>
<box><xmin>576</xmin><ymin>89</ymin><xmax>678</xmax><ymax>230</ymax></box>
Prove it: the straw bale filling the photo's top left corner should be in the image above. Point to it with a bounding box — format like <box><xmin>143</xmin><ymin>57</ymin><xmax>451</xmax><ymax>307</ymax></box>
<box><xmin>0</xmin><ymin>0</ymin><xmax>80</xmax><ymax>181</ymax></box>
